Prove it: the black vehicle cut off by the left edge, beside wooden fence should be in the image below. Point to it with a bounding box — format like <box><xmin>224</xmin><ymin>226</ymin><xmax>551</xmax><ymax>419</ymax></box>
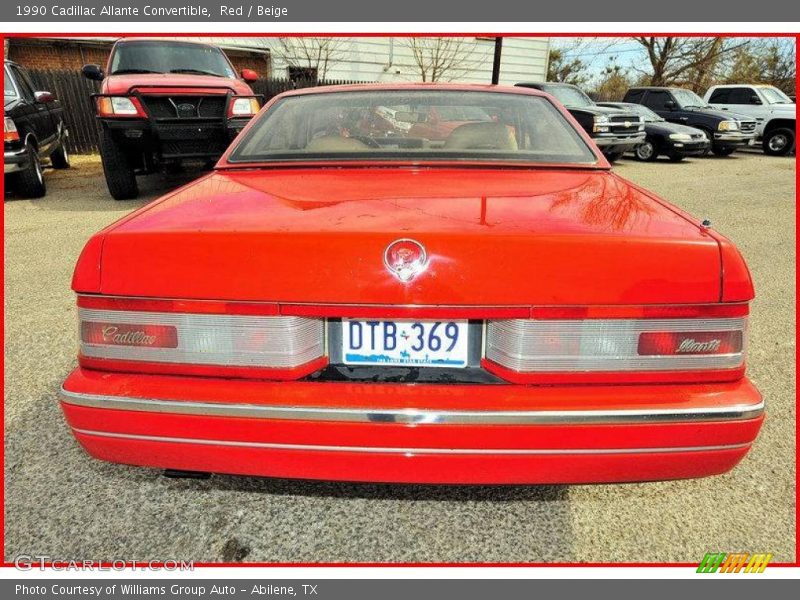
<box><xmin>3</xmin><ymin>60</ymin><xmax>69</xmax><ymax>198</ymax></box>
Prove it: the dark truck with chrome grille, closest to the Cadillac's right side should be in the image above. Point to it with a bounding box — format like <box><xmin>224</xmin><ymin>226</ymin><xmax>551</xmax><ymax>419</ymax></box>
<box><xmin>517</xmin><ymin>82</ymin><xmax>645</xmax><ymax>162</ymax></box>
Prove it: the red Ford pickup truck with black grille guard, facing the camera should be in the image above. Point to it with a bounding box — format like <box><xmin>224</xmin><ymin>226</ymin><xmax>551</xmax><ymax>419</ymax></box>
<box><xmin>83</xmin><ymin>38</ymin><xmax>261</xmax><ymax>200</ymax></box>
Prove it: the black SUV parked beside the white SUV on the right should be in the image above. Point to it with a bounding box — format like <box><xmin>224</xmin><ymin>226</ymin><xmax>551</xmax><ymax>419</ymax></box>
<box><xmin>624</xmin><ymin>87</ymin><xmax>756</xmax><ymax>156</ymax></box>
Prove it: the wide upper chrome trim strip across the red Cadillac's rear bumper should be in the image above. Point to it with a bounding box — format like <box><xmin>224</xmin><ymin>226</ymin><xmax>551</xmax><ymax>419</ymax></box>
<box><xmin>60</xmin><ymin>388</ymin><xmax>764</xmax><ymax>425</ymax></box>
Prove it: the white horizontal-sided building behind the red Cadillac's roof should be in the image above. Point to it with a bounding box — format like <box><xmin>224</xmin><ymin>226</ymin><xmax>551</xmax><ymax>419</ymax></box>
<box><xmin>268</xmin><ymin>37</ymin><xmax>550</xmax><ymax>84</ymax></box>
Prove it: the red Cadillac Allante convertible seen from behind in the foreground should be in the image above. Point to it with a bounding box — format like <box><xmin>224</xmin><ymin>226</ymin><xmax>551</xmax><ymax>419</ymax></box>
<box><xmin>61</xmin><ymin>84</ymin><xmax>764</xmax><ymax>483</ymax></box>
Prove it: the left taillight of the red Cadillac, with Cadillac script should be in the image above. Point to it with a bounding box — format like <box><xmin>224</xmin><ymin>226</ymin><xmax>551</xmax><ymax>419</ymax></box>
<box><xmin>78</xmin><ymin>301</ymin><xmax>325</xmax><ymax>379</ymax></box>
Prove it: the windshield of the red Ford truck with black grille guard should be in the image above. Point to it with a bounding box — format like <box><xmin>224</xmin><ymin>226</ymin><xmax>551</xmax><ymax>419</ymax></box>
<box><xmin>110</xmin><ymin>41</ymin><xmax>236</xmax><ymax>78</ymax></box>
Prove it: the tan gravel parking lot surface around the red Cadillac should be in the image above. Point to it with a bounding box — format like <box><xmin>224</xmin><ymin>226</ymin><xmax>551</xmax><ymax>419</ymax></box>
<box><xmin>4</xmin><ymin>153</ymin><xmax>796</xmax><ymax>562</ymax></box>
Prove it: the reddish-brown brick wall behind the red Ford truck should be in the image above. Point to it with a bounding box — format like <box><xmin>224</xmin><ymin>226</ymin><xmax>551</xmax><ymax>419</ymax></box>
<box><xmin>6</xmin><ymin>38</ymin><xmax>269</xmax><ymax>77</ymax></box>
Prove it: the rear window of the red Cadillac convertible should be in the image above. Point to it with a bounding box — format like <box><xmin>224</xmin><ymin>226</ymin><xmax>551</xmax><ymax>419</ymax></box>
<box><xmin>229</xmin><ymin>90</ymin><xmax>597</xmax><ymax>164</ymax></box>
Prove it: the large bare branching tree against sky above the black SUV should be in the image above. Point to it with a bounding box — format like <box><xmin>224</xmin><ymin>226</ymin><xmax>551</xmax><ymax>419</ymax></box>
<box><xmin>633</xmin><ymin>37</ymin><xmax>749</xmax><ymax>90</ymax></box>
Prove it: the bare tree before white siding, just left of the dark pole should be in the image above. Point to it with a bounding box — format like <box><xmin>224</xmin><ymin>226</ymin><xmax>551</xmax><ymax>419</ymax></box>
<box><xmin>404</xmin><ymin>37</ymin><xmax>477</xmax><ymax>82</ymax></box>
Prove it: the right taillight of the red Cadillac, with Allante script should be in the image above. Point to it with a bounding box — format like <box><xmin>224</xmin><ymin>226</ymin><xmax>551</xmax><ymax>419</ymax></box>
<box><xmin>485</xmin><ymin>309</ymin><xmax>747</xmax><ymax>382</ymax></box>
